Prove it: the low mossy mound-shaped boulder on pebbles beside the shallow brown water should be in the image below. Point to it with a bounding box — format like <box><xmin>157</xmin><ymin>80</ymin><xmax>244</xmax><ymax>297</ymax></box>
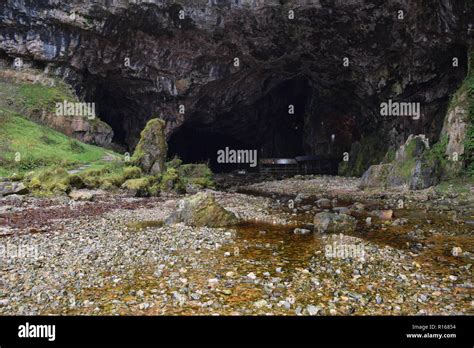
<box><xmin>165</xmin><ymin>192</ymin><xmax>238</xmax><ymax>227</ymax></box>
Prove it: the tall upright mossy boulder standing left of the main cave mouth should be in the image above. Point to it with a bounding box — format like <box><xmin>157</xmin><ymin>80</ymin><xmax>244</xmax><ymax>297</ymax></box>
<box><xmin>132</xmin><ymin>118</ymin><xmax>168</xmax><ymax>175</ymax></box>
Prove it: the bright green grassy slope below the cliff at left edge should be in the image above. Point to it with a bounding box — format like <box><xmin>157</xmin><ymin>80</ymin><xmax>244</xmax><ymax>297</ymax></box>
<box><xmin>0</xmin><ymin>74</ymin><xmax>117</xmax><ymax>176</ymax></box>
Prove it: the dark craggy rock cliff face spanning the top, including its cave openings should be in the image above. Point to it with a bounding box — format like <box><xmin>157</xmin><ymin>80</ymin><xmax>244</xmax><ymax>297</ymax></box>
<box><xmin>0</xmin><ymin>0</ymin><xmax>474</xmax><ymax>174</ymax></box>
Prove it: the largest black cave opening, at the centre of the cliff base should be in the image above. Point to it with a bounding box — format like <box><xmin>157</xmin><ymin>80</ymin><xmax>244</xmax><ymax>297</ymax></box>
<box><xmin>168</xmin><ymin>79</ymin><xmax>311</xmax><ymax>172</ymax></box>
